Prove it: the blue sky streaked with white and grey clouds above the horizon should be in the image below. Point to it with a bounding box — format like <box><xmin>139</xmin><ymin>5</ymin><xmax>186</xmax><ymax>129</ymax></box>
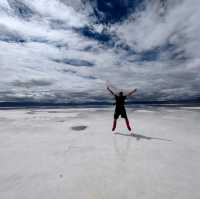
<box><xmin>0</xmin><ymin>0</ymin><xmax>200</xmax><ymax>102</ymax></box>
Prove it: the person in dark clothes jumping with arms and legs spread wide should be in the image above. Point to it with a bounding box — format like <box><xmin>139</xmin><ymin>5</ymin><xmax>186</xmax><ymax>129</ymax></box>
<box><xmin>107</xmin><ymin>86</ymin><xmax>137</xmax><ymax>131</ymax></box>
